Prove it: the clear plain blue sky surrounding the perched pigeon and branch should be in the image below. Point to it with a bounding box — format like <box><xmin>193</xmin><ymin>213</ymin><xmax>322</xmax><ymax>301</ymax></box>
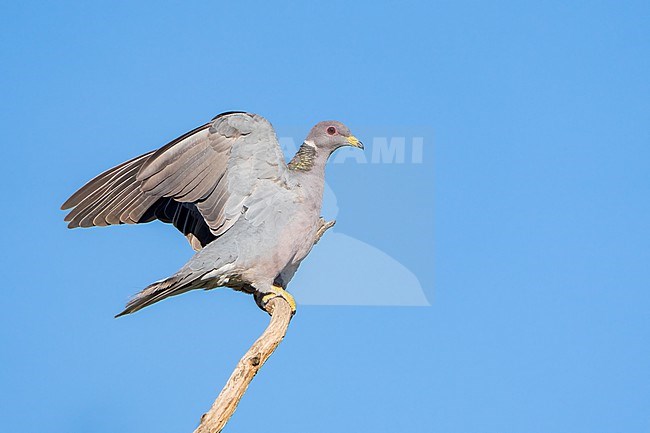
<box><xmin>0</xmin><ymin>1</ymin><xmax>650</xmax><ymax>433</ymax></box>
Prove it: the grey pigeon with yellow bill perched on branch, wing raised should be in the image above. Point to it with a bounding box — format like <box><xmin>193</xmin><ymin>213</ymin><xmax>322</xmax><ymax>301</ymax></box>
<box><xmin>61</xmin><ymin>112</ymin><xmax>363</xmax><ymax>317</ymax></box>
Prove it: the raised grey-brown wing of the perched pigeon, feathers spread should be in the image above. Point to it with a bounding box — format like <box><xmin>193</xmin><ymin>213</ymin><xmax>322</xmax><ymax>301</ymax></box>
<box><xmin>61</xmin><ymin>112</ymin><xmax>287</xmax><ymax>250</ymax></box>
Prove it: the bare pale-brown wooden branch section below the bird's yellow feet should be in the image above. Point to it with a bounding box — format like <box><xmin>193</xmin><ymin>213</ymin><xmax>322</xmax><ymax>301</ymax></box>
<box><xmin>194</xmin><ymin>297</ymin><xmax>291</xmax><ymax>433</ymax></box>
